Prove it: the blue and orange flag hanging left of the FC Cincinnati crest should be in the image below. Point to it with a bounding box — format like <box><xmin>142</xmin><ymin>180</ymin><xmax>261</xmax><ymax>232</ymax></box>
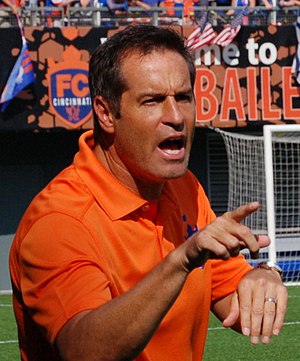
<box><xmin>0</xmin><ymin>19</ymin><xmax>35</xmax><ymax>111</ymax></box>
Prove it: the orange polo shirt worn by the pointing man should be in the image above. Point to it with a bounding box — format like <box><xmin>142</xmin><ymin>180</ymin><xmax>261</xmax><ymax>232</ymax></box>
<box><xmin>10</xmin><ymin>131</ymin><xmax>250</xmax><ymax>361</ymax></box>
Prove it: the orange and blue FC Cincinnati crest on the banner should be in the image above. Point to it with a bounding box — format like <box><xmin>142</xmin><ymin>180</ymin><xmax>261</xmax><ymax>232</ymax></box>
<box><xmin>46</xmin><ymin>45</ymin><xmax>92</xmax><ymax>128</ymax></box>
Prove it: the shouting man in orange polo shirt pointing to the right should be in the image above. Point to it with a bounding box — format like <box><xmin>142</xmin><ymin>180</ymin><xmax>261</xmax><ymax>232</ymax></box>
<box><xmin>10</xmin><ymin>25</ymin><xmax>287</xmax><ymax>361</ymax></box>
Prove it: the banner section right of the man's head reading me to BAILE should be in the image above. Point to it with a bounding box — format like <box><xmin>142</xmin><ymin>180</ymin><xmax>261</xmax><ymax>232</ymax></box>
<box><xmin>185</xmin><ymin>26</ymin><xmax>300</xmax><ymax>128</ymax></box>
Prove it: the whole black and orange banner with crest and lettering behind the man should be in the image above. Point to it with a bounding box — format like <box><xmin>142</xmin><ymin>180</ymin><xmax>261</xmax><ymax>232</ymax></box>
<box><xmin>0</xmin><ymin>25</ymin><xmax>300</xmax><ymax>130</ymax></box>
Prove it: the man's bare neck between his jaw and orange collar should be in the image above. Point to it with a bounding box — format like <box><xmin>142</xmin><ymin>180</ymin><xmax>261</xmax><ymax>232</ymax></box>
<box><xmin>94</xmin><ymin>144</ymin><xmax>164</xmax><ymax>201</ymax></box>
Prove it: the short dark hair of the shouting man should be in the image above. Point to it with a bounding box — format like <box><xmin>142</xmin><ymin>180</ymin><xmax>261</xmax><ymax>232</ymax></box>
<box><xmin>89</xmin><ymin>24</ymin><xmax>196</xmax><ymax>137</ymax></box>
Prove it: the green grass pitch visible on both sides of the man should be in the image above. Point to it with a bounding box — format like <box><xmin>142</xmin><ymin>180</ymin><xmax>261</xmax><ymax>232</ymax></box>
<box><xmin>0</xmin><ymin>287</ymin><xmax>300</xmax><ymax>361</ymax></box>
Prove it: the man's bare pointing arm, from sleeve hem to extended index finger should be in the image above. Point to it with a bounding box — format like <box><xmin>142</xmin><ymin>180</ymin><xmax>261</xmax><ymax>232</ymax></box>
<box><xmin>56</xmin><ymin>202</ymin><xmax>268</xmax><ymax>361</ymax></box>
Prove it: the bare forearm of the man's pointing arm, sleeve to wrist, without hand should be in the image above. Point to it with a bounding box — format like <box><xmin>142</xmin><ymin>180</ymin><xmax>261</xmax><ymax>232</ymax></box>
<box><xmin>56</xmin><ymin>252</ymin><xmax>188</xmax><ymax>361</ymax></box>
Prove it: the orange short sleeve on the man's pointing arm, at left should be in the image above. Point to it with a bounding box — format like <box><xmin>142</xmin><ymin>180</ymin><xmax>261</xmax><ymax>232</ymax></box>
<box><xmin>20</xmin><ymin>213</ymin><xmax>112</xmax><ymax>343</ymax></box>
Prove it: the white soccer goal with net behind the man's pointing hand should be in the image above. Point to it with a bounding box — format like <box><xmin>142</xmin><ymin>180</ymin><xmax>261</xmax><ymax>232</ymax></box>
<box><xmin>216</xmin><ymin>125</ymin><xmax>300</xmax><ymax>284</ymax></box>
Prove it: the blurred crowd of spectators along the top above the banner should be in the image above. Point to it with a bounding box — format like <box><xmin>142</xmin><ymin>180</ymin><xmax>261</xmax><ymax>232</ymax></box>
<box><xmin>0</xmin><ymin>0</ymin><xmax>300</xmax><ymax>27</ymax></box>
